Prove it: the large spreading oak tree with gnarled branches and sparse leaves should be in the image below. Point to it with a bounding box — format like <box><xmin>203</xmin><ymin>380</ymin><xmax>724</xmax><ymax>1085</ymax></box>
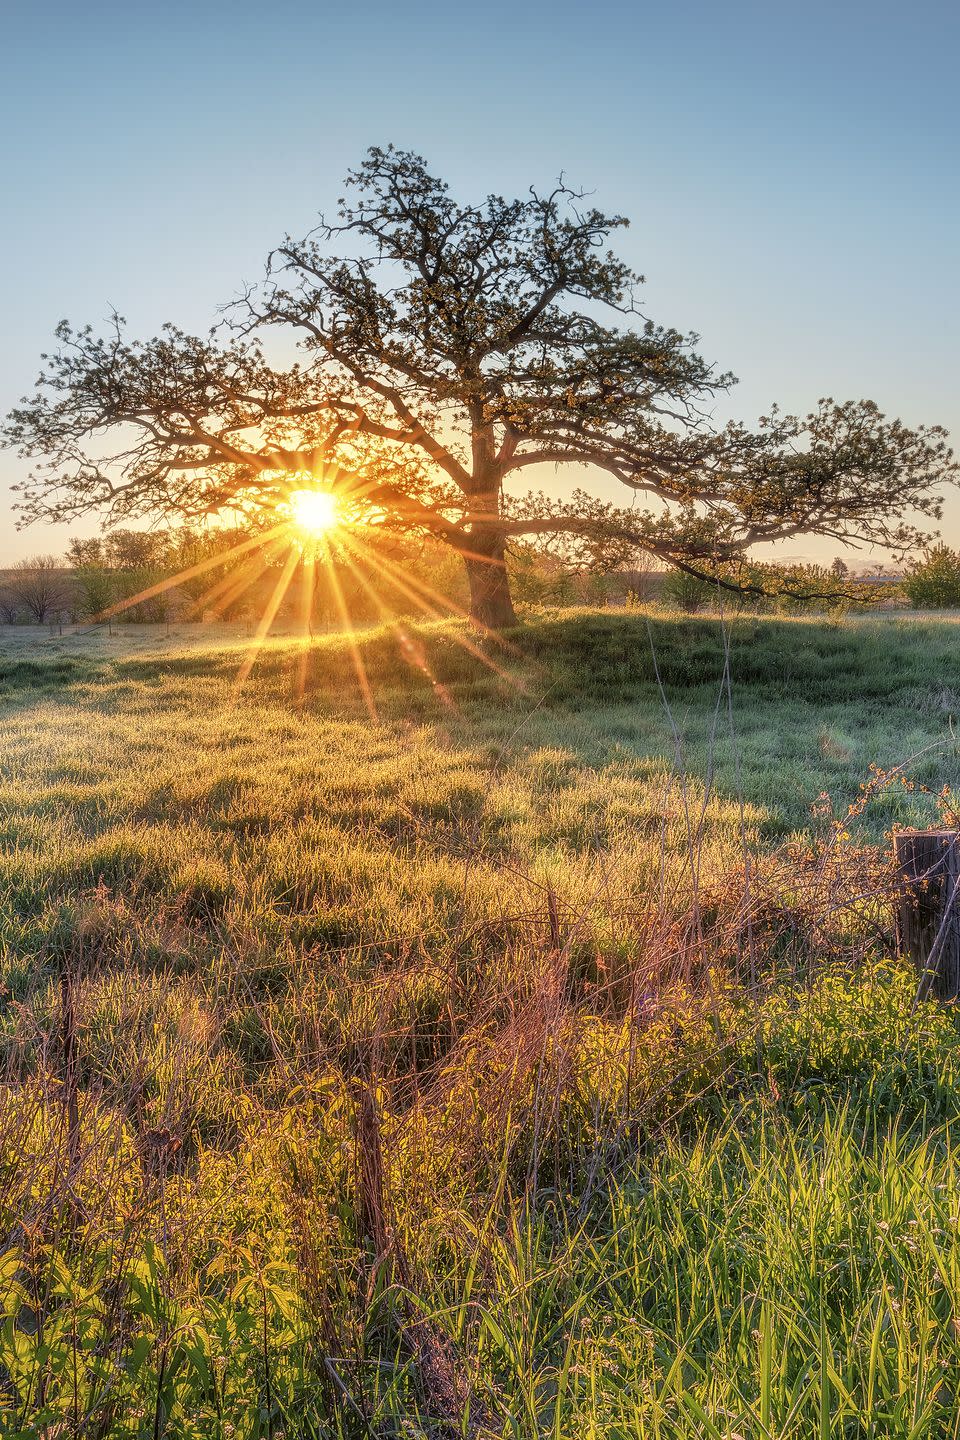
<box><xmin>7</xmin><ymin>148</ymin><xmax>954</xmax><ymax>628</ymax></box>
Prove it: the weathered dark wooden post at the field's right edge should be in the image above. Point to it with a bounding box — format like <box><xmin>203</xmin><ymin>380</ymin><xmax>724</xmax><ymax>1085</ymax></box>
<box><xmin>894</xmin><ymin>829</ymin><xmax>960</xmax><ymax>999</ymax></box>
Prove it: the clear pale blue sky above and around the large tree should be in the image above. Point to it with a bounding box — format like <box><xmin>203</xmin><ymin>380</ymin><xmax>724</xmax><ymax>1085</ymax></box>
<box><xmin>0</xmin><ymin>0</ymin><xmax>960</xmax><ymax>564</ymax></box>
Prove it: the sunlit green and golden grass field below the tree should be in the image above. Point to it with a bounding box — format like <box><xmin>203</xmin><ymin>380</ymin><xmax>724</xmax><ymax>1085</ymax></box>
<box><xmin>0</xmin><ymin>612</ymin><xmax>960</xmax><ymax>1440</ymax></box>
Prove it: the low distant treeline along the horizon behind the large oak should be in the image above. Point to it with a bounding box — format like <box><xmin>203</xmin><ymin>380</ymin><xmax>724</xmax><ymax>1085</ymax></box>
<box><xmin>0</xmin><ymin>527</ymin><xmax>960</xmax><ymax>628</ymax></box>
